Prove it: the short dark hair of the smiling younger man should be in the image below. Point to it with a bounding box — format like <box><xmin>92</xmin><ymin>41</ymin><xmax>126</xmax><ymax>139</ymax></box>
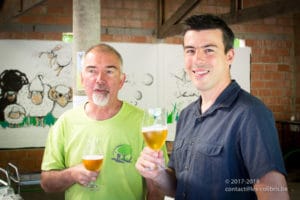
<box><xmin>183</xmin><ymin>14</ymin><xmax>234</xmax><ymax>53</ymax></box>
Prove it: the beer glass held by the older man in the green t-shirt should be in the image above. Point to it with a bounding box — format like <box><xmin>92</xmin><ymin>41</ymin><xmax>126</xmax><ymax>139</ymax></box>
<box><xmin>82</xmin><ymin>138</ymin><xmax>104</xmax><ymax>190</ymax></box>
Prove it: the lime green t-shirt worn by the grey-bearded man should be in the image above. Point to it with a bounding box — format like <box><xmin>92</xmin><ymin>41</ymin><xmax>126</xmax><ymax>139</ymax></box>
<box><xmin>42</xmin><ymin>102</ymin><xmax>167</xmax><ymax>200</ymax></box>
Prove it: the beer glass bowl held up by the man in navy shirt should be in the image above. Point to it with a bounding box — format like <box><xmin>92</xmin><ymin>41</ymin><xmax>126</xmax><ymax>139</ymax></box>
<box><xmin>142</xmin><ymin>108</ymin><xmax>168</xmax><ymax>151</ymax></box>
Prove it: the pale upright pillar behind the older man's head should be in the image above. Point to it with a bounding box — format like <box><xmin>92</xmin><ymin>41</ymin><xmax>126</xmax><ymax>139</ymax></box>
<box><xmin>72</xmin><ymin>0</ymin><xmax>101</xmax><ymax>95</ymax></box>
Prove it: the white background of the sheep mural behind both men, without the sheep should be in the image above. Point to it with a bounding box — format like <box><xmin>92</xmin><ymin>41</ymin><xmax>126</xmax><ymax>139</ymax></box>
<box><xmin>0</xmin><ymin>40</ymin><xmax>251</xmax><ymax>148</ymax></box>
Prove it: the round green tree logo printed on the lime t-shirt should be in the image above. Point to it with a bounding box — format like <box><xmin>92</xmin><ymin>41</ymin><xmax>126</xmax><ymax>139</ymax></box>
<box><xmin>112</xmin><ymin>144</ymin><xmax>132</xmax><ymax>163</ymax></box>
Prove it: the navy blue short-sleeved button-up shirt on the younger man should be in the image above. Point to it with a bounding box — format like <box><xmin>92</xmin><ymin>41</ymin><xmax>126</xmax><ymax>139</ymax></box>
<box><xmin>169</xmin><ymin>81</ymin><xmax>286</xmax><ymax>200</ymax></box>
